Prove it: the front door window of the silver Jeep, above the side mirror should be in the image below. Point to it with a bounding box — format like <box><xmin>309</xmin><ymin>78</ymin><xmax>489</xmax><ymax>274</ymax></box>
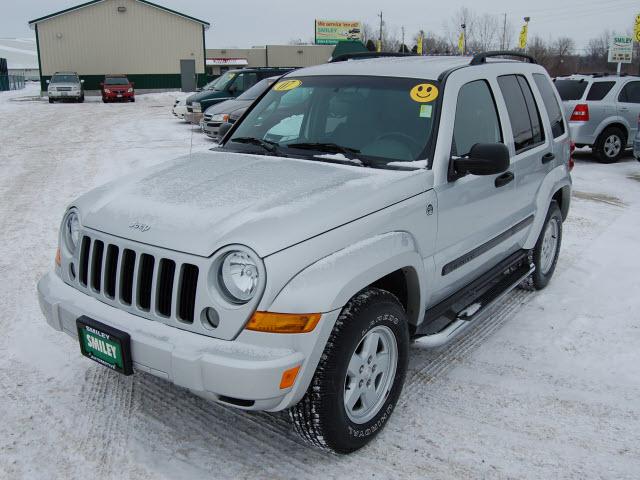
<box><xmin>452</xmin><ymin>80</ymin><xmax>502</xmax><ymax>156</ymax></box>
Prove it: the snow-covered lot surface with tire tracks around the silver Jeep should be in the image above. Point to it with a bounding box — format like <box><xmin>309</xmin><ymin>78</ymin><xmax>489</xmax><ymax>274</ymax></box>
<box><xmin>0</xmin><ymin>86</ymin><xmax>640</xmax><ymax>480</ymax></box>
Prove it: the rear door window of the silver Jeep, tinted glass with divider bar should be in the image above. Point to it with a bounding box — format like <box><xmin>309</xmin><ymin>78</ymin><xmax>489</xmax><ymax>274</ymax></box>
<box><xmin>498</xmin><ymin>75</ymin><xmax>544</xmax><ymax>153</ymax></box>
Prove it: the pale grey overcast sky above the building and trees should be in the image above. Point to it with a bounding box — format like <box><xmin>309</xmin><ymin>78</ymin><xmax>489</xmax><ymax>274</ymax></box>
<box><xmin>0</xmin><ymin>0</ymin><xmax>640</xmax><ymax>48</ymax></box>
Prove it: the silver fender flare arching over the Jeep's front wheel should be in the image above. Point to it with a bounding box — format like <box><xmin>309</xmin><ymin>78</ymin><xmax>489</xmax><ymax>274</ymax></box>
<box><xmin>269</xmin><ymin>231</ymin><xmax>425</xmax><ymax>321</ymax></box>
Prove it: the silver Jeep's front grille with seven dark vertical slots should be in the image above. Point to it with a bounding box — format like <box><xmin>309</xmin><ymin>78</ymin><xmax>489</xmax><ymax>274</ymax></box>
<box><xmin>78</xmin><ymin>235</ymin><xmax>199</xmax><ymax>323</ymax></box>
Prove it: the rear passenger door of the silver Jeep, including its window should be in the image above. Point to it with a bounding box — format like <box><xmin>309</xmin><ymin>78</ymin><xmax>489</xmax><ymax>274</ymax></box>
<box><xmin>498</xmin><ymin>74</ymin><xmax>552</xmax><ymax>231</ymax></box>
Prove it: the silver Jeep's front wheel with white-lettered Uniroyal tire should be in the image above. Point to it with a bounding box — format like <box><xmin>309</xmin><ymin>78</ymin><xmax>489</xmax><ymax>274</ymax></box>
<box><xmin>289</xmin><ymin>288</ymin><xmax>409</xmax><ymax>453</ymax></box>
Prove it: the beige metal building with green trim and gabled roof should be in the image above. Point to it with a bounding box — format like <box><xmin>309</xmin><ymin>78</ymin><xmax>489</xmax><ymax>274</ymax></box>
<box><xmin>29</xmin><ymin>0</ymin><xmax>209</xmax><ymax>91</ymax></box>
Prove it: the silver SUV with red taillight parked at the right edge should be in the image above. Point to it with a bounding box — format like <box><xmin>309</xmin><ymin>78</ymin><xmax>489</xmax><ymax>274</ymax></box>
<box><xmin>555</xmin><ymin>74</ymin><xmax>640</xmax><ymax>163</ymax></box>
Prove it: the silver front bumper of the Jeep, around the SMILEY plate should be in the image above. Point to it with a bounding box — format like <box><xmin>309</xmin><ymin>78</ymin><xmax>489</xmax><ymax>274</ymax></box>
<box><xmin>38</xmin><ymin>272</ymin><xmax>339</xmax><ymax>411</ymax></box>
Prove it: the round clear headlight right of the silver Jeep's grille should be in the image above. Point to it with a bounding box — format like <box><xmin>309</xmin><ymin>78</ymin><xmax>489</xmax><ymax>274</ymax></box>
<box><xmin>219</xmin><ymin>251</ymin><xmax>260</xmax><ymax>303</ymax></box>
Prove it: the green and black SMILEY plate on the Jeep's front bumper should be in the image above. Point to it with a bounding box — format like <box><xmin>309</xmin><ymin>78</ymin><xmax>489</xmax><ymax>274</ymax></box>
<box><xmin>76</xmin><ymin>316</ymin><xmax>133</xmax><ymax>375</ymax></box>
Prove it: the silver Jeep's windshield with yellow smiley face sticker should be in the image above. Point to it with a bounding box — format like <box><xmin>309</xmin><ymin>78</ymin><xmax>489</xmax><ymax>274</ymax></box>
<box><xmin>225</xmin><ymin>76</ymin><xmax>438</xmax><ymax>168</ymax></box>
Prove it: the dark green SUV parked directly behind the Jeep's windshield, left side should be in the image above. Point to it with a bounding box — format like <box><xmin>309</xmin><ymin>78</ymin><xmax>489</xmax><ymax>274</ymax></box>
<box><xmin>185</xmin><ymin>67</ymin><xmax>292</xmax><ymax>125</ymax></box>
